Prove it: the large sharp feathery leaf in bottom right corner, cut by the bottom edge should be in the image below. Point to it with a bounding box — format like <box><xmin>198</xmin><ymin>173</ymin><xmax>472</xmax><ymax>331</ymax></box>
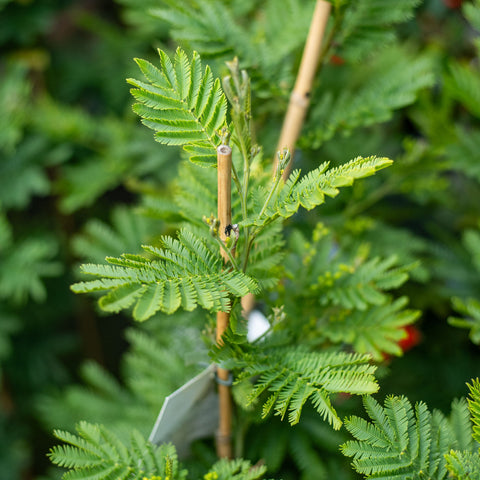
<box><xmin>341</xmin><ymin>396</ymin><xmax>471</xmax><ymax>479</ymax></box>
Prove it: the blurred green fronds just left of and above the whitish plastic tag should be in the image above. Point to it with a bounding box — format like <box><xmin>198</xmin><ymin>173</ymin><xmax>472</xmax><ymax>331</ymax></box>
<box><xmin>37</xmin><ymin>312</ymin><xmax>208</xmax><ymax>439</ymax></box>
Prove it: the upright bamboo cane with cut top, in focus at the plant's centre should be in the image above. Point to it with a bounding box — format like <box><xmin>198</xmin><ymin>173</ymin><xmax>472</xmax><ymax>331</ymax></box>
<box><xmin>216</xmin><ymin>145</ymin><xmax>232</xmax><ymax>458</ymax></box>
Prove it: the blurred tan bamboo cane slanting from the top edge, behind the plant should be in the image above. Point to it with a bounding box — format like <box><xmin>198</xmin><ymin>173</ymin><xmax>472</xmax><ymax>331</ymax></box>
<box><xmin>274</xmin><ymin>0</ymin><xmax>331</xmax><ymax>180</ymax></box>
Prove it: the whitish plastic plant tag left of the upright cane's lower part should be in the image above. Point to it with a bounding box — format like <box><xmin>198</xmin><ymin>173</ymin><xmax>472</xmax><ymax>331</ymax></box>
<box><xmin>149</xmin><ymin>364</ymin><xmax>218</xmax><ymax>456</ymax></box>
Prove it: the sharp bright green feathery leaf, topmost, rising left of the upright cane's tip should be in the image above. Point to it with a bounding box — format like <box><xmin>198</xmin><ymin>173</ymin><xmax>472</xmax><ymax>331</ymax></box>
<box><xmin>128</xmin><ymin>48</ymin><xmax>227</xmax><ymax>165</ymax></box>
